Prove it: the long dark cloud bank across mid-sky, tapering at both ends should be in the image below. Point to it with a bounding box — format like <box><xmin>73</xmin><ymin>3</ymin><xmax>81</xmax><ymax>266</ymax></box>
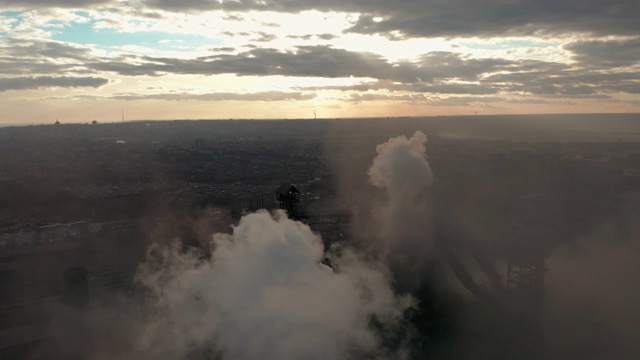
<box><xmin>87</xmin><ymin>46</ymin><xmax>559</xmax><ymax>85</ymax></box>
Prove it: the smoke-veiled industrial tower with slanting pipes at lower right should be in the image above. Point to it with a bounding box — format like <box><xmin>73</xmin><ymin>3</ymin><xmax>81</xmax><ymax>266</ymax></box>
<box><xmin>436</xmin><ymin>218</ymin><xmax>547</xmax><ymax>359</ymax></box>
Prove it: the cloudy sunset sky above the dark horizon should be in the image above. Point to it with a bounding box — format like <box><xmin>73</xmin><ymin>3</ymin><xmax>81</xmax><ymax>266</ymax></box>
<box><xmin>0</xmin><ymin>0</ymin><xmax>640</xmax><ymax>124</ymax></box>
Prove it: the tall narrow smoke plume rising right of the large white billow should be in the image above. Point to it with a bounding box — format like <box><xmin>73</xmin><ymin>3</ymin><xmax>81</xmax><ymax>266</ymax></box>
<box><xmin>369</xmin><ymin>131</ymin><xmax>433</xmax><ymax>282</ymax></box>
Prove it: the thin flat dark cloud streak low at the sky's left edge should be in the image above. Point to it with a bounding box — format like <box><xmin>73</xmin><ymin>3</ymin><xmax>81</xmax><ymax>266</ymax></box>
<box><xmin>0</xmin><ymin>76</ymin><xmax>109</xmax><ymax>92</ymax></box>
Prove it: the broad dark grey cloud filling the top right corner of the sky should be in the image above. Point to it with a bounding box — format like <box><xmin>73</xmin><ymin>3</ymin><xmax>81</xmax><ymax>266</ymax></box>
<box><xmin>349</xmin><ymin>0</ymin><xmax>640</xmax><ymax>38</ymax></box>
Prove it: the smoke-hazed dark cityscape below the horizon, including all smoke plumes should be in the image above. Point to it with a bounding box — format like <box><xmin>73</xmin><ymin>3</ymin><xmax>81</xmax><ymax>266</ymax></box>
<box><xmin>0</xmin><ymin>114</ymin><xmax>640</xmax><ymax>359</ymax></box>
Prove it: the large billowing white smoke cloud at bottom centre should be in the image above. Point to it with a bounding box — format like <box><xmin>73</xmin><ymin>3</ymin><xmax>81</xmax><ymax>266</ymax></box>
<box><xmin>87</xmin><ymin>211</ymin><xmax>413</xmax><ymax>360</ymax></box>
